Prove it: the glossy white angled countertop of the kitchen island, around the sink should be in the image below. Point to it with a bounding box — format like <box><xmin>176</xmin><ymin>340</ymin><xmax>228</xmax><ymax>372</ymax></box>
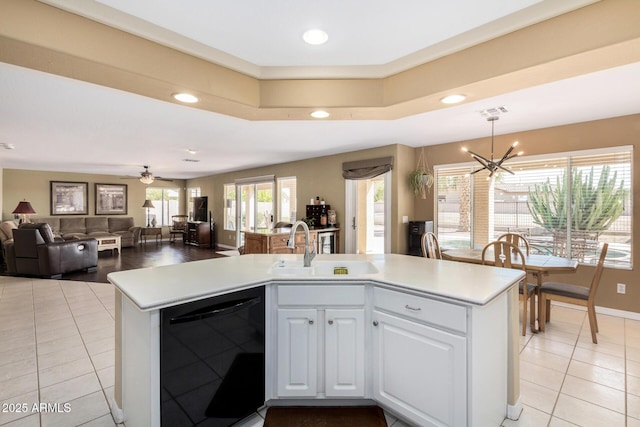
<box><xmin>107</xmin><ymin>254</ymin><xmax>524</xmax><ymax>311</ymax></box>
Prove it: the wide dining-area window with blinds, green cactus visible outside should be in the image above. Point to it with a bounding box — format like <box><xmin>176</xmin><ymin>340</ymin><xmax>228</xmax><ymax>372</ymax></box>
<box><xmin>435</xmin><ymin>147</ymin><xmax>633</xmax><ymax>268</ymax></box>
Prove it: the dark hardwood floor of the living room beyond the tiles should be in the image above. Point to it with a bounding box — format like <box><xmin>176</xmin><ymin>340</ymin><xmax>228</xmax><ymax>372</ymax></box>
<box><xmin>2</xmin><ymin>241</ymin><xmax>225</xmax><ymax>283</ymax></box>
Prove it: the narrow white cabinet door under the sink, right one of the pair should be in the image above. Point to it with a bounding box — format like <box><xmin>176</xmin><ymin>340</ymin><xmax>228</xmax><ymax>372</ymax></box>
<box><xmin>324</xmin><ymin>309</ymin><xmax>365</xmax><ymax>397</ymax></box>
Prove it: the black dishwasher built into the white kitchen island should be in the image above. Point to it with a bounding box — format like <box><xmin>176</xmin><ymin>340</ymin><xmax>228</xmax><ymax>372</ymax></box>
<box><xmin>160</xmin><ymin>286</ymin><xmax>265</xmax><ymax>427</ymax></box>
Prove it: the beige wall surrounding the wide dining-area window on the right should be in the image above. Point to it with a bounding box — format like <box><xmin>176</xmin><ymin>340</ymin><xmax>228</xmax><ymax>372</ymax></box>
<box><xmin>415</xmin><ymin>114</ymin><xmax>640</xmax><ymax>313</ymax></box>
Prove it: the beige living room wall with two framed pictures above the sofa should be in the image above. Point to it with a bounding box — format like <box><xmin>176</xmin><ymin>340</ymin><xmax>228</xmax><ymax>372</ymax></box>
<box><xmin>1</xmin><ymin>169</ymin><xmax>185</xmax><ymax>226</ymax></box>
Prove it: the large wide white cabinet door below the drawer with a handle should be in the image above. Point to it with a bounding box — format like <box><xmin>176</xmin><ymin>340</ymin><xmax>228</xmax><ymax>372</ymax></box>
<box><xmin>373</xmin><ymin>311</ymin><xmax>467</xmax><ymax>426</ymax></box>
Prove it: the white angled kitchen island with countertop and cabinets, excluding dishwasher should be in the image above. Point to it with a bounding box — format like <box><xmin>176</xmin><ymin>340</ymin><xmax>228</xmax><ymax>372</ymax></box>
<box><xmin>108</xmin><ymin>254</ymin><xmax>523</xmax><ymax>426</ymax></box>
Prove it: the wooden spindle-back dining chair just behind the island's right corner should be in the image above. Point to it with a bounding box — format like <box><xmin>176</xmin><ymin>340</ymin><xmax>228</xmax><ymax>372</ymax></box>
<box><xmin>482</xmin><ymin>240</ymin><xmax>536</xmax><ymax>336</ymax></box>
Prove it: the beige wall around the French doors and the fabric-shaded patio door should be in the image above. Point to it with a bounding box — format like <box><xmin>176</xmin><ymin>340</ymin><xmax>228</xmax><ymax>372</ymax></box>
<box><xmin>187</xmin><ymin>145</ymin><xmax>413</xmax><ymax>253</ymax></box>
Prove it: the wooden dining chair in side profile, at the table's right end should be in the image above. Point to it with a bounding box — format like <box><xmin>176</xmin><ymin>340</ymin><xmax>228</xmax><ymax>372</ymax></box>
<box><xmin>539</xmin><ymin>243</ymin><xmax>609</xmax><ymax>344</ymax></box>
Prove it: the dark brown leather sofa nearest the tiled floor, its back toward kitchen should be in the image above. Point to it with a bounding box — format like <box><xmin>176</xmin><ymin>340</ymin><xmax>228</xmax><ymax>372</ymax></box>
<box><xmin>5</xmin><ymin>223</ymin><xmax>98</xmax><ymax>279</ymax></box>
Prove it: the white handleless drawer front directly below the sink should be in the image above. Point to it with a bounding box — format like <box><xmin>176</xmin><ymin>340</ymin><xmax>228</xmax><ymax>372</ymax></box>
<box><xmin>278</xmin><ymin>284</ymin><xmax>365</xmax><ymax>306</ymax></box>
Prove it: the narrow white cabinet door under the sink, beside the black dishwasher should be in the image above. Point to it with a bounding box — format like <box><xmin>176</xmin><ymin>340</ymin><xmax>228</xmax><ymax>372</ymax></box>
<box><xmin>277</xmin><ymin>308</ymin><xmax>318</xmax><ymax>396</ymax></box>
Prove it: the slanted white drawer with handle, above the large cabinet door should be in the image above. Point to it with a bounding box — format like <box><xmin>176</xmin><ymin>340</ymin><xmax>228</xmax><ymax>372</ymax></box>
<box><xmin>373</xmin><ymin>287</ymin><xmax>467</xmax><ymax>332</ymax></box>
